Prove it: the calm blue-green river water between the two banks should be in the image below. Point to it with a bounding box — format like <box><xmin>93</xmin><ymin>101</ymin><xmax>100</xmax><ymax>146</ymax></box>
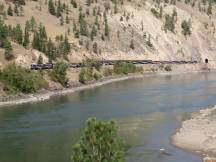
<box><xmin>0</xmin><ymin>73</ymin><xmax>216</xmax><ymax>162</ymax></box>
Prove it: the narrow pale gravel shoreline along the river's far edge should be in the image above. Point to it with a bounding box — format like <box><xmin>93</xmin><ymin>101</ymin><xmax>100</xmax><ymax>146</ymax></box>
<box><xmin>0</xmin><ymin>67</ymin><xmax>210</xmax><ymax>108</ymax></box>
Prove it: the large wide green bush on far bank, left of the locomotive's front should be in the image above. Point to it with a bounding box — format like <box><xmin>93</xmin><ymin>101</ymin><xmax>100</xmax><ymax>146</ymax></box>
<box><xmin>0</xmin><ymin>64</ymin><xmax>47</xmax><ymax>93</ymax></box>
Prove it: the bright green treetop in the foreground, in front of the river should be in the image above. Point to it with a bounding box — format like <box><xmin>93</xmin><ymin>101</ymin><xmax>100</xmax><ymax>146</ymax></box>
<box><xmin>71</xmin><ymin>118</ymin><xmax>125</xmax><ymax>162</ymax></box>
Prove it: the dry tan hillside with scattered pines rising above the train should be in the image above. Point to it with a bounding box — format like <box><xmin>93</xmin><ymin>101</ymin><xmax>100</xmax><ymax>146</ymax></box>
<box><xmin>0</xmin><ymin>0</ymin><xmax>216</xmax><ymax>66</ymax></box>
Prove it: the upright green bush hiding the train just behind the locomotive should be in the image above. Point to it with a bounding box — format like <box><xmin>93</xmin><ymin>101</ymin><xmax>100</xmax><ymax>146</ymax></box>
<box><xmin>50</xmin><ymin>62</ymin><xmax>68</xmax><ymax>87</ymax></box>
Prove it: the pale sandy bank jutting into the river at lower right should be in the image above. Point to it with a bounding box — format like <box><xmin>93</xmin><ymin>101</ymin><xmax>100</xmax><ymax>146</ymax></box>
<box><xmin>171</xmin><ymin>106</ymin><xmax>216</xmax><ymax>162</ymax></box>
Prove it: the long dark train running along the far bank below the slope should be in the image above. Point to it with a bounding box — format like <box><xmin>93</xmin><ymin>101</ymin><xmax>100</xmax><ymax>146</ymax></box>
<box><xmin>31</xmin><ymin>60</ymin><xmax>198</xmax><ymax>70</ymax></box>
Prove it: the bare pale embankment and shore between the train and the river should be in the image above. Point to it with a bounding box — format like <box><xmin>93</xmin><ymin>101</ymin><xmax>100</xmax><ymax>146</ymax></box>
<box><xmin>0</xmin><ymin>64</ymin><xmax>209</xmax><ymax>107</ymax></box>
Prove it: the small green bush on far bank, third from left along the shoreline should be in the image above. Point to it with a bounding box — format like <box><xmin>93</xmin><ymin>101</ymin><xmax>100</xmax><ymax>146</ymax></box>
<box><xmin>79</xmin><ymin>67</ymin><xmax>94</xmax><ymax>83</ymax></box>
